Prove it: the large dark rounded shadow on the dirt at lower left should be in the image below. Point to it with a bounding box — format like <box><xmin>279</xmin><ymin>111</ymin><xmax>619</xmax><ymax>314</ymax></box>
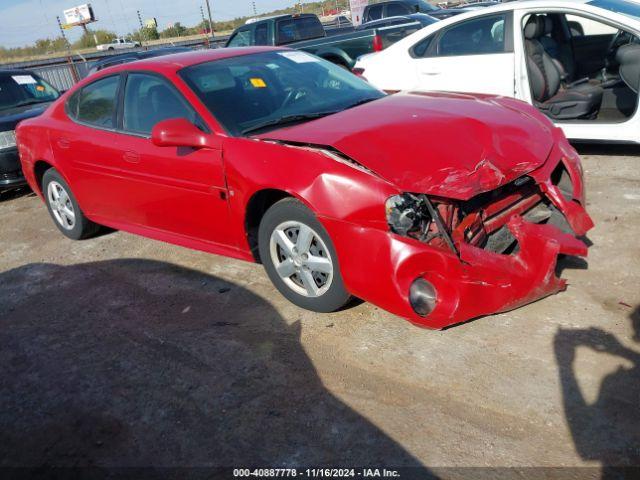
<box><xmin>0</xmin><ymin>259</ymin><xmax>426</xmax><ymax>472</ymax></box>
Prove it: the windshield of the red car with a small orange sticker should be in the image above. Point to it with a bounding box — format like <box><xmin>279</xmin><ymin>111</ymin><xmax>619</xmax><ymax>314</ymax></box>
<box><xmin>179</xmin><ymin>50</ymin><xmax>384</xmax><ymax>135</ymax></box>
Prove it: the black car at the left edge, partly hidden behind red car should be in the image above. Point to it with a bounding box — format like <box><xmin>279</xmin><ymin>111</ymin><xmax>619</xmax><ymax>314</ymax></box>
<box><xmin>0</xmin><ymin>70</ymin><xmax>60</xmax><ymax>190</ymax></box>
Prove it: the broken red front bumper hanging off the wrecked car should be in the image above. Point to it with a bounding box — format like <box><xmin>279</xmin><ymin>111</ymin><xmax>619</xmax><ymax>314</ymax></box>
<box><xmin>322</xmin><ymin>142</ymin><xmax>593</xmax><ymax>329</ymax></box>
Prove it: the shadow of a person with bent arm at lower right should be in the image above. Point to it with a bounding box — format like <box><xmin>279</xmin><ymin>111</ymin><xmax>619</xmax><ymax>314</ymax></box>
<box><xmin>554</xmin><ymin>306</ymin><xmax>640</xmax><ymax>479</ymax></box>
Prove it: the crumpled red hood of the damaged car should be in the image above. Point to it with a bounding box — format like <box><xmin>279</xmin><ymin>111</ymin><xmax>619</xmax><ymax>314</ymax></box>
<box><xmin>257</xmin><ymin>93</ymin><xmax>553</xmax><ymax>200</ymax></box>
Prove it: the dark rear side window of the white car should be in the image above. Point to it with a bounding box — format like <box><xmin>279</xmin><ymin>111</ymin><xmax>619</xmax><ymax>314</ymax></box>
<box><xmin>436</xmin><ymin>15</ymin><xmax>506</xmax><ymax>56</ymax></box>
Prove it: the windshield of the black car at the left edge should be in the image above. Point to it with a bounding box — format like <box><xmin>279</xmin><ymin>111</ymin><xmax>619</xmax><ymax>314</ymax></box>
<box><xmin>0</xmin><ymin>72</ymin><xmax>60</xmax><ymax>110</ymax></box>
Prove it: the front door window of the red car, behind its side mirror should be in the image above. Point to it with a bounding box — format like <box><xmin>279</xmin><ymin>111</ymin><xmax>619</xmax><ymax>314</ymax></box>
<box><xmin>122</xmin><ymin>73</ymin><xmax>196</xmax><ymax>135</ymax></box>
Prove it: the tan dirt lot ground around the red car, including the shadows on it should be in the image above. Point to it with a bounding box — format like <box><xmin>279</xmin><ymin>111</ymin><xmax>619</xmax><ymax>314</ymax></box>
<box><xmin>0</xmin><ymin>147</ymin><xmax>640</xmax><ymax>478</ymax></box>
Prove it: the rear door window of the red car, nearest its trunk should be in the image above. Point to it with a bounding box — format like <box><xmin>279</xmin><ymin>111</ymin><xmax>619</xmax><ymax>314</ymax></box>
<box><xmin>67</xmin><ymin>75</ymin><xmax>120</xmax><ymax>128</ymax></box>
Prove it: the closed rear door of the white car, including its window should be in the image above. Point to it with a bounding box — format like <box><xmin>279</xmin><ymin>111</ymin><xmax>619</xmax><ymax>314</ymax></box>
<box><xmin>411</xmin><ymin>12</ymin><xmax>515</xmax><ymax>97</ymax></box>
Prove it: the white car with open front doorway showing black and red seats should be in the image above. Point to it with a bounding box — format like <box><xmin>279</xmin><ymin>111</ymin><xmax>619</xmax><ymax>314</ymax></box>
<box><xmin>354</xmin><ymin>0</ymin><xmax>640</xmax><ymax>143</ymax></box>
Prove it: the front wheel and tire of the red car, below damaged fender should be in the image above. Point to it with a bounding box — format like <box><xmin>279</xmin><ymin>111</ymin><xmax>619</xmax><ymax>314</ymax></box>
<box><xmin>258</xmin><ymin>198</ymin><xmax>350</xmax><ymax>313</ymax></box>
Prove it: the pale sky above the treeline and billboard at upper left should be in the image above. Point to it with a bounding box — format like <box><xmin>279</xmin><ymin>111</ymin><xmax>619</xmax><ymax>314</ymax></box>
<box><xmin>0</xmin><ymin>0</ymin><xmax>304</xmax><ymax>47</ymax></box>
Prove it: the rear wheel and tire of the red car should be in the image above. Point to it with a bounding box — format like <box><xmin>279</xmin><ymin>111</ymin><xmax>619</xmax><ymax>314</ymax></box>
<box><xmin>42</xmin><ymin>168</ymin><xmax>100</xmax><ymax>240</ymax></box>
